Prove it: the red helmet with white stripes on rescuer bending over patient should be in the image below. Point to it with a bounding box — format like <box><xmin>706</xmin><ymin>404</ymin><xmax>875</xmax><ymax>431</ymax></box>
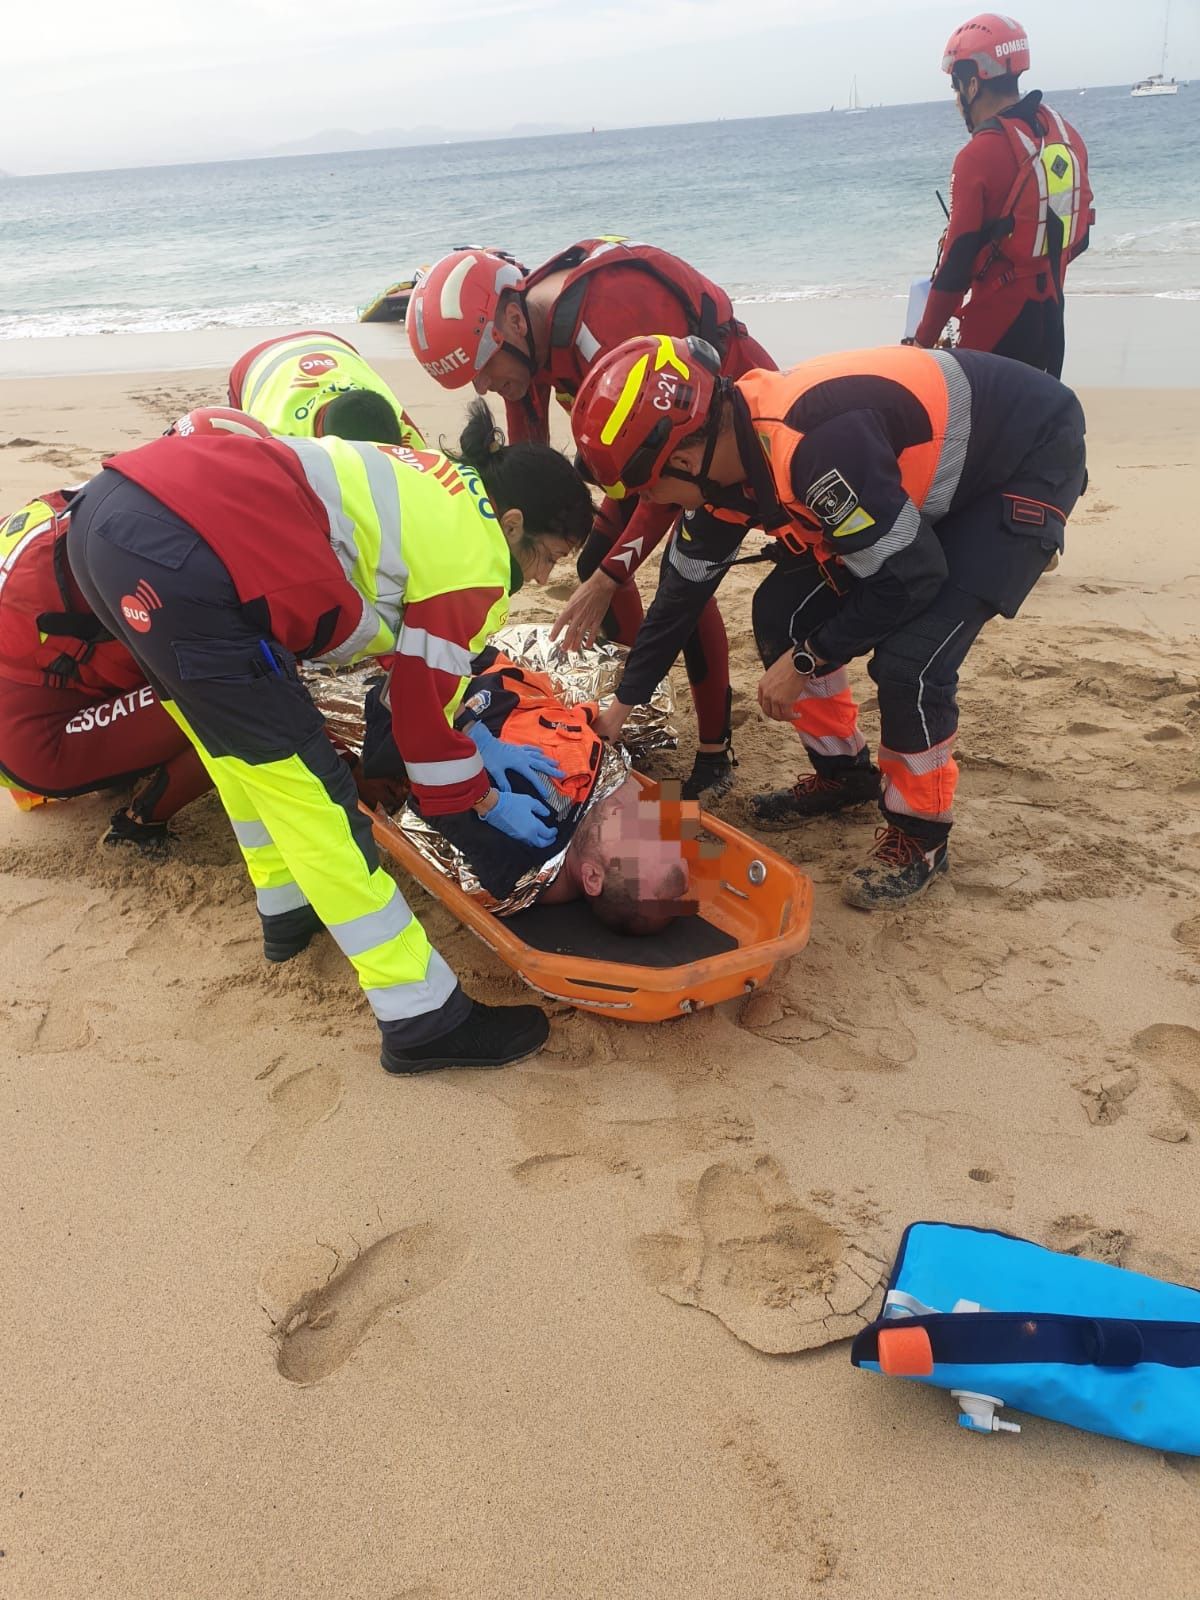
<box><xmin>405</xmin><ymin>250</ymin><xmax>525</xmax><ymax>389</ymax></box>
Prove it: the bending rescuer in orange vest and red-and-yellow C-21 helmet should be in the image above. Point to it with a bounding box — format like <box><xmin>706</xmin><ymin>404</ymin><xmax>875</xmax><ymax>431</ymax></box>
<box><xmin>571</xmin><ymin>338</ymin><xmax>1086</xmax><ymax>909</ymax></box>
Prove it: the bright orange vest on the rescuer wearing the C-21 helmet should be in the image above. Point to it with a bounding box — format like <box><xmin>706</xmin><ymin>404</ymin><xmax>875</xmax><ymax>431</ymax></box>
<box><xmin>734</xmin><ymin>346</ymin><xmax>950</xmax><ymax>562</ymax></box>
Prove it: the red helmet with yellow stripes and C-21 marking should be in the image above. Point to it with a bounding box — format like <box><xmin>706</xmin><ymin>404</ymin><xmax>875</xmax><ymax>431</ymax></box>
<box><xmin>571</xmin><ymin>333</ymin><xmax>722</xmax><ymax>499</ymax></box>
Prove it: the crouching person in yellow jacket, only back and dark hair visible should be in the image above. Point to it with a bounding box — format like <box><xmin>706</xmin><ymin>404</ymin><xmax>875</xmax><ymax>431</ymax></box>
<box><xmin>229</xmin><ymin>331</ymin><xmax>426</xmax><ymax>450</ymax></box>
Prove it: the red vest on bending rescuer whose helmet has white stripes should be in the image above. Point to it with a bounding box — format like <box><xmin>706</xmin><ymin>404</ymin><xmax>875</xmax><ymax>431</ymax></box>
<box><xmin>522</xmin><ymin>238</ymin><xmax>736</xmax><ymax>395</ymax></box>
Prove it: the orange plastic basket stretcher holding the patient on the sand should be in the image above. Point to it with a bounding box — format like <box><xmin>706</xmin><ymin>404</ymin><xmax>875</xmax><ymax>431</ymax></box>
<box><xmin>370</xmin><ymin>774</ymin><xmax>813</xmax><ymax>1022</ymax></box>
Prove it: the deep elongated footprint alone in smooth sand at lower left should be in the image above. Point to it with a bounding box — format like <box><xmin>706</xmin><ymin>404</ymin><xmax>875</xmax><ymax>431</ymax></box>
<box><xmin>261</xmin><ymin>1222</ymin><xmax>466</xmax><ymax>1384</ymax></box>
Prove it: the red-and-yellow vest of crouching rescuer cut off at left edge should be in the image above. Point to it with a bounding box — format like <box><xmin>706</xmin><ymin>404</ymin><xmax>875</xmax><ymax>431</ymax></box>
<box><xmin>0</xmin><ymin>491</ymin><xmax>146</xmax><ymax>696</ymax></box>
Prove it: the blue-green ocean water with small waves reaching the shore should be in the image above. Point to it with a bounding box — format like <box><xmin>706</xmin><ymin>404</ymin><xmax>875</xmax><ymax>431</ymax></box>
<box><xmin>0</xmin><ymin>85</ymin><xmax>1200</xmax><ymax>338</ymax></box>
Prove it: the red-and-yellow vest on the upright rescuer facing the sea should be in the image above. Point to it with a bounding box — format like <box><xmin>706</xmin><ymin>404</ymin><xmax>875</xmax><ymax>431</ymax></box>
<box><xmin>979</xmin><ymin>106</ymin><xmax>1091</xmax><ymax>290</ymax></box>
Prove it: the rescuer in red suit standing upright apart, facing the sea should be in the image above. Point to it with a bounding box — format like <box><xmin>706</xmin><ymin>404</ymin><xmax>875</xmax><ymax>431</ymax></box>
<box><xmin>915</xmin><ymin>13</ymin><xmax>1096</xmax><ymax>378</ymax></box>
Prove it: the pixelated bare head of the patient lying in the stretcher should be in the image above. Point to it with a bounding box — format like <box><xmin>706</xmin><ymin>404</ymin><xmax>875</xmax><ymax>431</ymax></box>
<box><xmin>571</xmin><ymin>778</ymin><xmax>696</xmax><ymax>934</ymax></box>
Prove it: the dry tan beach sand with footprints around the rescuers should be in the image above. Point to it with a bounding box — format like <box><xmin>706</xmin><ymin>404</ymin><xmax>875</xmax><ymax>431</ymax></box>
<box><xmin>0</xmin><ymin>344</ymin><xmax>1200</xmax><ymax>1600</ymax></box>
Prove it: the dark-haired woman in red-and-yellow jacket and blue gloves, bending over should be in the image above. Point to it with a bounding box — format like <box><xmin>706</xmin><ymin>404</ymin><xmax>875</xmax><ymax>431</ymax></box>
<box><xmin>67</xmin><ymin>405</ymin><xmax>592</xmax><ymax>1072</ymax></box>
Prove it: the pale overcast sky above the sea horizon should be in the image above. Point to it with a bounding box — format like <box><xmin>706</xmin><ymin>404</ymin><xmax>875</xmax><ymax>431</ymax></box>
<box><xmin>0</xmin><ymin>0</ymin><xmax>1200</xmax><ymax>173</ymax></box>
